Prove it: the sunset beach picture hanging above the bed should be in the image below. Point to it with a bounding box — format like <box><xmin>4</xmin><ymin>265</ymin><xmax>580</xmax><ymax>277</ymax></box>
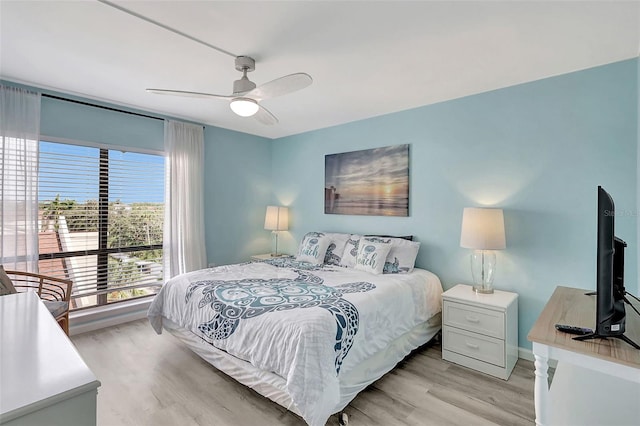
<box><xmin>324</xmin><ymin>144</ymin><xmax>409</xmax><ymax>216</ymax></box>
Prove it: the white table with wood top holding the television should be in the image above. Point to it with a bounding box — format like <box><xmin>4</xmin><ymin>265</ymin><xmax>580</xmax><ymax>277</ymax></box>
<box><xmin>528</xmin><ymin>286</ymin><xmax>640</xmax><ymax>426</ymax></box>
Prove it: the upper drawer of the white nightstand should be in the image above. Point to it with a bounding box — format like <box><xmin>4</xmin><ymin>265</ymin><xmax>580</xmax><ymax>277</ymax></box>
<box><xmin>443</xmin><ymin>300</ymin><xmax>504</xmax><ymax>339</ymax></box>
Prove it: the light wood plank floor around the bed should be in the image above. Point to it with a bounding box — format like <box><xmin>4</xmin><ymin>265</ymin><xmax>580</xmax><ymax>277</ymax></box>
<box><xmin>72</xmin><ymin>319</ymin><xmax>534</xmax><ymax>426</ymax></box>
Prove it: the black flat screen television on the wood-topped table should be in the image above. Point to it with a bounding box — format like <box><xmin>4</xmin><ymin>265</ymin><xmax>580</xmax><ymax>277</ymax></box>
<box><xmin>575</xmin><ymin>186</ymin><xmax>640</xmax><ymax>349</ymax></box>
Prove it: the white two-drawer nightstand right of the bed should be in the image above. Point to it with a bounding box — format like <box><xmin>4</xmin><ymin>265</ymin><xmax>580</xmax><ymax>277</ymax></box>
<box><xmin>442</xmin><ymin>284</ymin><xmax>518</xmax><ymax>380</ymax></box>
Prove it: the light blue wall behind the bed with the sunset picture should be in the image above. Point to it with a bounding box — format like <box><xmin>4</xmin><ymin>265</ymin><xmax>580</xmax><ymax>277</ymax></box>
<box><xmin>272</xmin><ymin>59</ymin><xmax>638</xmax><ymax>348</ymax></box>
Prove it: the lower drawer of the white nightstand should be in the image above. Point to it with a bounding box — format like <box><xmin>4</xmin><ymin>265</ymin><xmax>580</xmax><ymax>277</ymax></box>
<box><xmin>442</xmin><ymin>327</ymin><xmax>505</xmax><ymax>367</ymax></box>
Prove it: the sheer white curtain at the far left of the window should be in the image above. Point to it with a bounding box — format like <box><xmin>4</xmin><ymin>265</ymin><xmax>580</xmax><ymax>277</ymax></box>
<box><xmin>0</xmin><ymin>85</ymin><xmax>40</xmax><ymax>272</ymax></box>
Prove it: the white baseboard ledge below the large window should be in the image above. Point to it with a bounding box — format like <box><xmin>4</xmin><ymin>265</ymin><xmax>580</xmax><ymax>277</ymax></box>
<box><xmin>69</xmin><ymin>298</ymin><xmax>152</xmax><ymax>336</ymax></box>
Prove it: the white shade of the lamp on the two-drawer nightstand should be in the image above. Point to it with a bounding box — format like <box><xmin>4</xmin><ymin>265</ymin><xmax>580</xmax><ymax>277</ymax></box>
<box><xmin>460</xmin><ymin>207</ymin><xmax>507</xmax><ymax>250</ymax></box>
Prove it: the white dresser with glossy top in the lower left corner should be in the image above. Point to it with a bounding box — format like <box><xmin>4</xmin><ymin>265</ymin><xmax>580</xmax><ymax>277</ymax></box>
<box><xmin>0</xmin><ymin>292</ymin><xmax>100</xmax><ymax>426</ymax></box>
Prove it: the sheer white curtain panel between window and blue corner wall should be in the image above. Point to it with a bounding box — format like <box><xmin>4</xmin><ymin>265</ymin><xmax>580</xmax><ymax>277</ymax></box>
<box><xmin>163</xmin><ymin>120</ymin><xmax>207</xmax><ymax>279</ymax></box>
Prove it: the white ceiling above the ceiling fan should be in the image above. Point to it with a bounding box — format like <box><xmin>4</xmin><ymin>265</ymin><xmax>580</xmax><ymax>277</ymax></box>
<box><xmin>0</xmin><ymin>0</ymin><xmax>640</xmax><ymax>138</ymax></box>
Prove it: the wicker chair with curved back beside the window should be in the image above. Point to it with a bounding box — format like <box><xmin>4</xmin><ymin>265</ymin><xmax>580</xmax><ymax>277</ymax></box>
<box><xmin>6</xmin><ymin>271</ymin><xmax>73</xmax><ymax>336</ymax></box>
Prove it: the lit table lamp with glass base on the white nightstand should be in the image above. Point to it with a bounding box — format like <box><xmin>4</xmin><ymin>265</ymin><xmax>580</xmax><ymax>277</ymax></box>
<box><xmin>460</xmin><ymin>207</ymin><xmax>507</xmax><ymax>293</ymax></box>
